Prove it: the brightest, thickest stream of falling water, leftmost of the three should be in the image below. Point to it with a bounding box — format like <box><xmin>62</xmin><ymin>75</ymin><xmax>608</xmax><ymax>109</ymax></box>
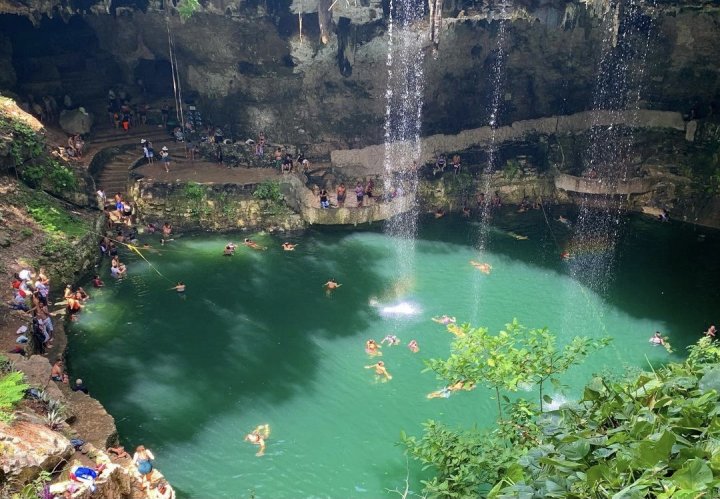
<box><xmin>384</xmin><ymin>0</ymin><xmax>428</xmax><ymax>308</ymax></box>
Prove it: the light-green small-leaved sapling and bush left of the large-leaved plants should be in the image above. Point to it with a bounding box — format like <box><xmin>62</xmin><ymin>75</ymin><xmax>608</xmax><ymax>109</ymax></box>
<box><xmin>402</xmin><ymin>320</ymin><xmax>608</xmax><ymax>498</ymax></box>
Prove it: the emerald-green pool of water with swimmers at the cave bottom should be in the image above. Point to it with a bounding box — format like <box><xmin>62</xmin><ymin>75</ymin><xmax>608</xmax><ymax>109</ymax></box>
<box><xmin>69</xmin><ymin>212</ymin><xmax>720</xmax><ymax>498</ymax></box>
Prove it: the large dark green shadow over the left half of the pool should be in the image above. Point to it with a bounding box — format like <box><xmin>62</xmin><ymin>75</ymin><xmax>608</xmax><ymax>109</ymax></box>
<box><xmin>69</xmin><ymin>230</ymin><xmax>396</xmax><ymax>445</ymax></box>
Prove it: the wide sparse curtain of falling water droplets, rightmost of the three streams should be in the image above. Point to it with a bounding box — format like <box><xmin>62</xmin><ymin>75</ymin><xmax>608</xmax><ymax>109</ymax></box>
<box><xmin>568</xmin><ymin>0</ymin><xmax>653</xmax><ymax>293</ymax></box>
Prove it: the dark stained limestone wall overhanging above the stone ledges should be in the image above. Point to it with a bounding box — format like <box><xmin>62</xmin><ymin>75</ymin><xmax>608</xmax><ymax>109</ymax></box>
<box><xmin>0</xmin><ymin>0</ymin><xmax>720</xmax><ymax>150</ymax></box>
